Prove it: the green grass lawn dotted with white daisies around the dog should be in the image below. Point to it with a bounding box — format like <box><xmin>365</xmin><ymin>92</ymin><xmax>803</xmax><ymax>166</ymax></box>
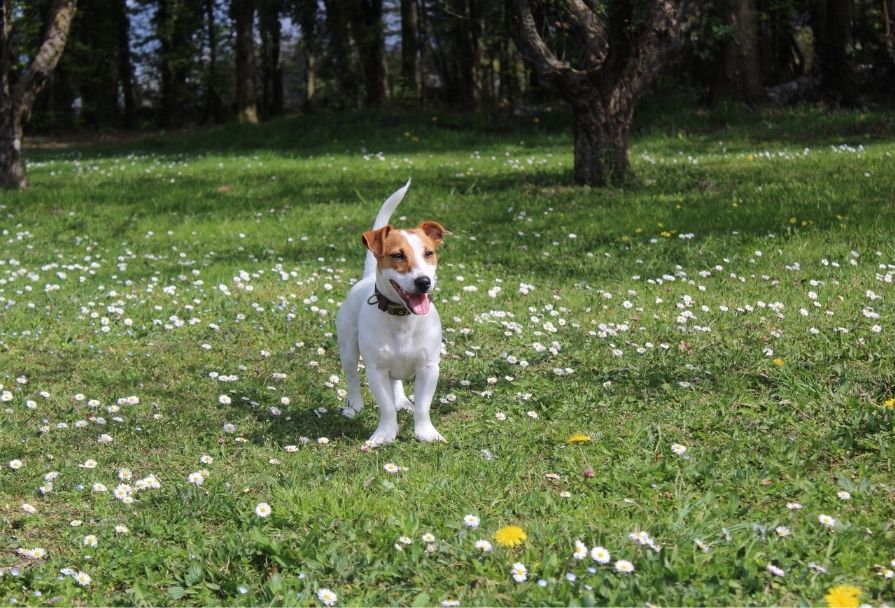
<box><xmin>0</xmin><ymin>104</ymin><xmax>895</xmax><ymax>605</ymax></box>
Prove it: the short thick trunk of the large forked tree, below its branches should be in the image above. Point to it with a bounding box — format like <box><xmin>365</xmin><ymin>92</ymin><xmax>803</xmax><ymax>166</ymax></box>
<box><xmin>572</xmin><ymin>100</ymin><xmax>634</xmax><ymax>186</ymax></box>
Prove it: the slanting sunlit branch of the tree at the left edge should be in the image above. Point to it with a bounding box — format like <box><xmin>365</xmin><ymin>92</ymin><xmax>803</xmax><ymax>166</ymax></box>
<box><xmin>13</xmin><ymin>0</ymin><xmax>77</xmax><ymax>124</ymax></box>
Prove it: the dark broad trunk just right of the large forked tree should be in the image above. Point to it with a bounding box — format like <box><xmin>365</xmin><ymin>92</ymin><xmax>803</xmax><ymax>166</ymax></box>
<box><xmin>712</xmin><ymin>0</ymin><xmax>765</xmax><ymax>103</ymax></box>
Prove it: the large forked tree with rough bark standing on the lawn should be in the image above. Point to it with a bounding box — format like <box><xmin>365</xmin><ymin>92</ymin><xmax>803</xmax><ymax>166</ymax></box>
<box><xmin>511</xmin><ymin>0</ymin><xmax>690</xmax><ymax>186</ymax></box>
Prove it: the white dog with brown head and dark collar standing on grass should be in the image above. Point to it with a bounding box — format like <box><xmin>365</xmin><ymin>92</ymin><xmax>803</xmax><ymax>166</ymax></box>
<box><xmin>336</xmin><ymin>180</ymin><xmax>450</xmax><ymax>446</ymax></box>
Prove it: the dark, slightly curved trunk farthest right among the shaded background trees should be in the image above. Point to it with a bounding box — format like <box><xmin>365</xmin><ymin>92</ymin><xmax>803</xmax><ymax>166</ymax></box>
<box><xmin>811</xmin><ymin>0</ymin><xmax>859</xmax><ymax>107</ymax></box>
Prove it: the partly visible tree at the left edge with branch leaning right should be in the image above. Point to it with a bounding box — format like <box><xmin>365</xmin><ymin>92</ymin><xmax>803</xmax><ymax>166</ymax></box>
<box><xmin>0</xmin><ymin>0</ymin><xmax>77</xmax><ymax>188</ymax></box>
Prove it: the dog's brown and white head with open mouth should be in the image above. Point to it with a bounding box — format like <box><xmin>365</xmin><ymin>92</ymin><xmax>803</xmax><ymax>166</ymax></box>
<box><xmin>361</xmin><ymin>221</ymin><xmax>450</xmax><ymax>315</ymax></box>
